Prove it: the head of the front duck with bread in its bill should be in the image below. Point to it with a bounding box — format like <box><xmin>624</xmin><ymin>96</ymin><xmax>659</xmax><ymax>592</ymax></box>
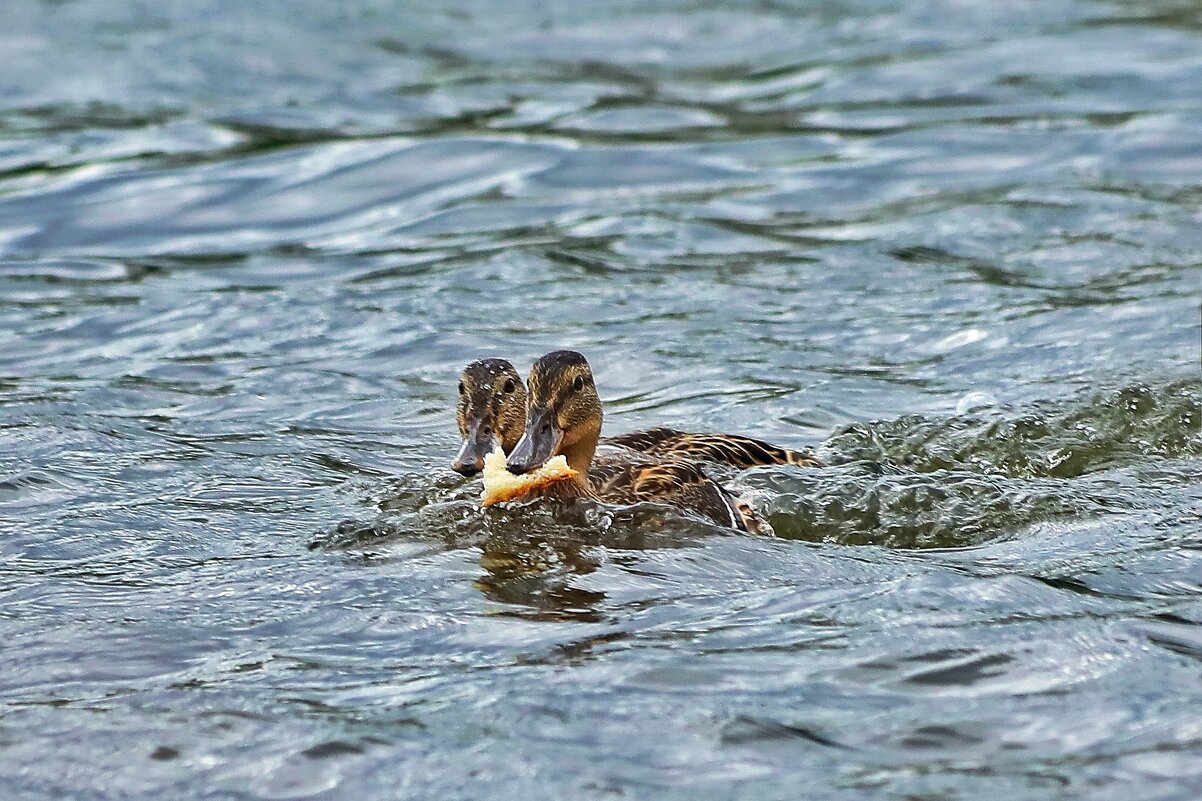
<box><xmin>505</xmin><ymin>350</ymin><xmax>602</xmax><ymax>476</ymax></box>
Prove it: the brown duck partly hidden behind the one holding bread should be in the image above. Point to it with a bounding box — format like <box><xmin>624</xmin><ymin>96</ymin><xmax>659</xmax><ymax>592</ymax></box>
<box><xmin>451</xmin><ymin>351</ymin><xmax>823</xmax><ymax>476</ymax></box>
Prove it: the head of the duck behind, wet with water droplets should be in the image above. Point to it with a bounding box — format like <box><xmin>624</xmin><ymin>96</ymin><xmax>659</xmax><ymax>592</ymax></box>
<box><xmin>451</xmin><ymin>358</ymin><xmax>526</xmax><ymax>475</ymax></box>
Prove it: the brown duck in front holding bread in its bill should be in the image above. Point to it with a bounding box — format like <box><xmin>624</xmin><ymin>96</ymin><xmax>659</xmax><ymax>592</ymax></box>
<box><xmin>505</xmin><ymin>350</ymin><xmax>770</xmax><ymax>532</ymax></box>
